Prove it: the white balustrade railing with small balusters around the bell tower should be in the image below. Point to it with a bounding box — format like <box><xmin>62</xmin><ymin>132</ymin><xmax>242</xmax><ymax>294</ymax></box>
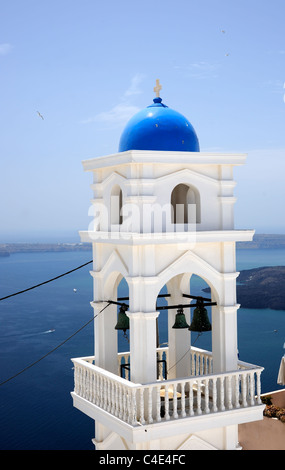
<box><xmin>72</xmin><ymin>348</ymin><xmax>263</xmax><ymax>426</ymax></box>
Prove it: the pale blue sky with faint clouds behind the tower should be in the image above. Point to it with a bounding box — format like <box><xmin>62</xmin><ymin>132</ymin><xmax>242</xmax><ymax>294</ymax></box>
<box><xmin>0</xmin><ymin>0</ymin><xmax>285</xmax><ymax>243</ymax></box>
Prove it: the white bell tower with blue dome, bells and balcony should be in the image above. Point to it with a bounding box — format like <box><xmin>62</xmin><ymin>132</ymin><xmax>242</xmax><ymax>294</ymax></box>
<box><xmin>72</xmin><ymin>83</ymin><xmax>264</xmax><ymax>450</ymax></box>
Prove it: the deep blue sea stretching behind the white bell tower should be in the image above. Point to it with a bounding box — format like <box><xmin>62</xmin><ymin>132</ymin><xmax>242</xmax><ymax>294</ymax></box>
<box><xmin>0</xmin><ymin>249</ymin><xmax>285</xmax><ymax>450</ymax></box>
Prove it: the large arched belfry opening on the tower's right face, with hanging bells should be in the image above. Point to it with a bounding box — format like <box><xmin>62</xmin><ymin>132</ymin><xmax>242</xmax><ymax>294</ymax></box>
<box><xmin>154</xmin><ymin>273</ymin><xmax>215</xmax><ymax>379</ymax></box>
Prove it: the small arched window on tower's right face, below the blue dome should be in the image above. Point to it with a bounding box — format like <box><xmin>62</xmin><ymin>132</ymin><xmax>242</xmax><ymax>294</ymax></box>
<box><xmin>171</xmin><ymin>183</ymin><xmax>201</xmax><ymax>224</ymax></box>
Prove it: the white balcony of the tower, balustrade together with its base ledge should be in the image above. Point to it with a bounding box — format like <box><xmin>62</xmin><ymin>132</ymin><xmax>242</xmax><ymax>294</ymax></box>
<box><xmin>72</xmin><ymin>348</ymin><xmax>264</xmax><ymax>440</ymax></box>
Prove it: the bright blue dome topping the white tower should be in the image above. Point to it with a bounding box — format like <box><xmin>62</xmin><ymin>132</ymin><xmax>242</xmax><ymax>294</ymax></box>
<box><xmin>116</xmin><ymin>98</ymin><xmax>200</xmax><ymax>152</ymax></box>
